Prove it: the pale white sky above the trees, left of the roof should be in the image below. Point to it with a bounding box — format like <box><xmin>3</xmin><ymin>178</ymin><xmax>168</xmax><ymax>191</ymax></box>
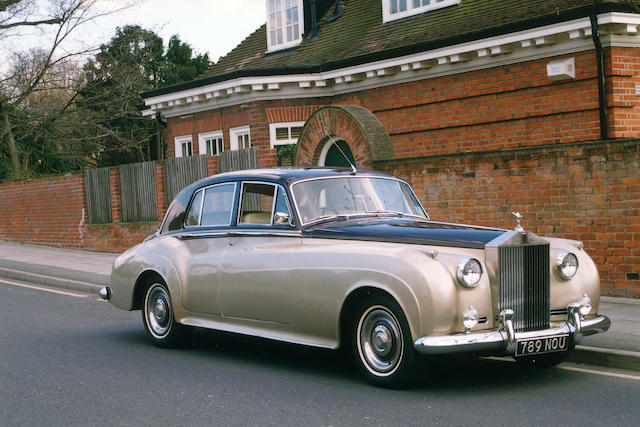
<box><xmin>0</xmin><ymin>0</ymin><xmax>266</xmax><ymax>65</ymax></box>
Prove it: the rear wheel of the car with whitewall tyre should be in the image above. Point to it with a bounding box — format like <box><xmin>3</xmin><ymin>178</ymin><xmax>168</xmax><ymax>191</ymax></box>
<box><xmin>142</xmin><ymin>283</ymin><xmax>190</xmax><ymax>348</ymax></box>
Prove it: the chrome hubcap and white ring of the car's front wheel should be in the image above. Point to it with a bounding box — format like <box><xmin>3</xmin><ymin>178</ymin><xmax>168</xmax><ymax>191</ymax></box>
<box><xmin>358</xmin><ymin>306</ymin><xmax>404</xmax><ymax>376</ymax></box>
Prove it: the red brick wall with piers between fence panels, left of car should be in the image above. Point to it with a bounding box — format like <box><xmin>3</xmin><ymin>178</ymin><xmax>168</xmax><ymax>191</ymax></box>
<box><xmin>0</xmin><ymin>157</ymin><xmax>218</xmax><ymax>252</ymax></box>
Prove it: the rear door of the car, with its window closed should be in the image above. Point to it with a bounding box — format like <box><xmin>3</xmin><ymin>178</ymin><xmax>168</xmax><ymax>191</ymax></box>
<box><xmin>175</xmin><ymin>183</ymin><xmax>236</xmax><ymax>315</ymax></box>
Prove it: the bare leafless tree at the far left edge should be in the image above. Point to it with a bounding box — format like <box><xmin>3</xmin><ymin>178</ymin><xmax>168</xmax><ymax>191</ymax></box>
<box><xmin>0</xmin><ymin>0</ymin><xmax>130</xmax><ymax>179</ymax></box>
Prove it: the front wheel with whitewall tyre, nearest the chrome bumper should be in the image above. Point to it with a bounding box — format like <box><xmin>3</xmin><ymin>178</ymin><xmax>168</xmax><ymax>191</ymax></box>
<box><xmin>351</xmin><ymin>295</ymin><xmax>416</xmax><ymax>388</ymax></box>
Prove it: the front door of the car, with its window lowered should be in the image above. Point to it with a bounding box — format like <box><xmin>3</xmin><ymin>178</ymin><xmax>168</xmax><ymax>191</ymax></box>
<box><xmin>221</xmin><ymin>182</ymin><xmax>300</xmax><ymax>324</ymax></box>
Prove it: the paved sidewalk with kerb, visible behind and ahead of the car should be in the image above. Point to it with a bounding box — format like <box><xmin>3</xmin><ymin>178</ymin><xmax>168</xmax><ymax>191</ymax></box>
<box><xmin>0</xmin><ymin>240</ymin><xmax>640</xmax><ymax>371</ymax></box>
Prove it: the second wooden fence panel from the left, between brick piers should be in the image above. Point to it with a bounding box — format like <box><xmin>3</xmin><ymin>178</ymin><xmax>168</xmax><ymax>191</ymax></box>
<box><xmin>118</xmin><ymin>162</ymin><xmax>158</xmax><ymax>222</ymax></box>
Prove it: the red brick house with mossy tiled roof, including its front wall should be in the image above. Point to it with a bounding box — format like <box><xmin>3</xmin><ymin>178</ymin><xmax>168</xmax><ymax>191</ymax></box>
<box><xmin>143</xmin><ymin>0</ymin><xmax>640</xmax><ymax>296</ymax></box>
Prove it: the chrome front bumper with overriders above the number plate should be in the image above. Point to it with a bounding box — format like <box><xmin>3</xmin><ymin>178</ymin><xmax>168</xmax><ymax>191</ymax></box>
<box><xmin>414</xmin><ymin>306</ymin><xmax>611</xmax><ymax>355</ymax></box>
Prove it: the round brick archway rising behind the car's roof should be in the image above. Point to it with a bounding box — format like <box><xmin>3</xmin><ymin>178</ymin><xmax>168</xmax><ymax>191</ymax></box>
<box><xmin>295</xmin><ymin>105</ymin><xmax>393</xmax><ymax>169</ymax></box>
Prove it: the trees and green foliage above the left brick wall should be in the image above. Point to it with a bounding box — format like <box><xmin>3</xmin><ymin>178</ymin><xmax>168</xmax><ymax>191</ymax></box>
<box><xmin>0</xmin><ymin>15</ymin><xmax>210</xmax><ymax>180</ymax></box>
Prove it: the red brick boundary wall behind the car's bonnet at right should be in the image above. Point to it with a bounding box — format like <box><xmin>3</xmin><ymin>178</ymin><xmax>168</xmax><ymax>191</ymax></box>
<box><xmin>376</xmin><ymin>140</ymin><xmax>640</xmax><ymax>298</ymax></box>
